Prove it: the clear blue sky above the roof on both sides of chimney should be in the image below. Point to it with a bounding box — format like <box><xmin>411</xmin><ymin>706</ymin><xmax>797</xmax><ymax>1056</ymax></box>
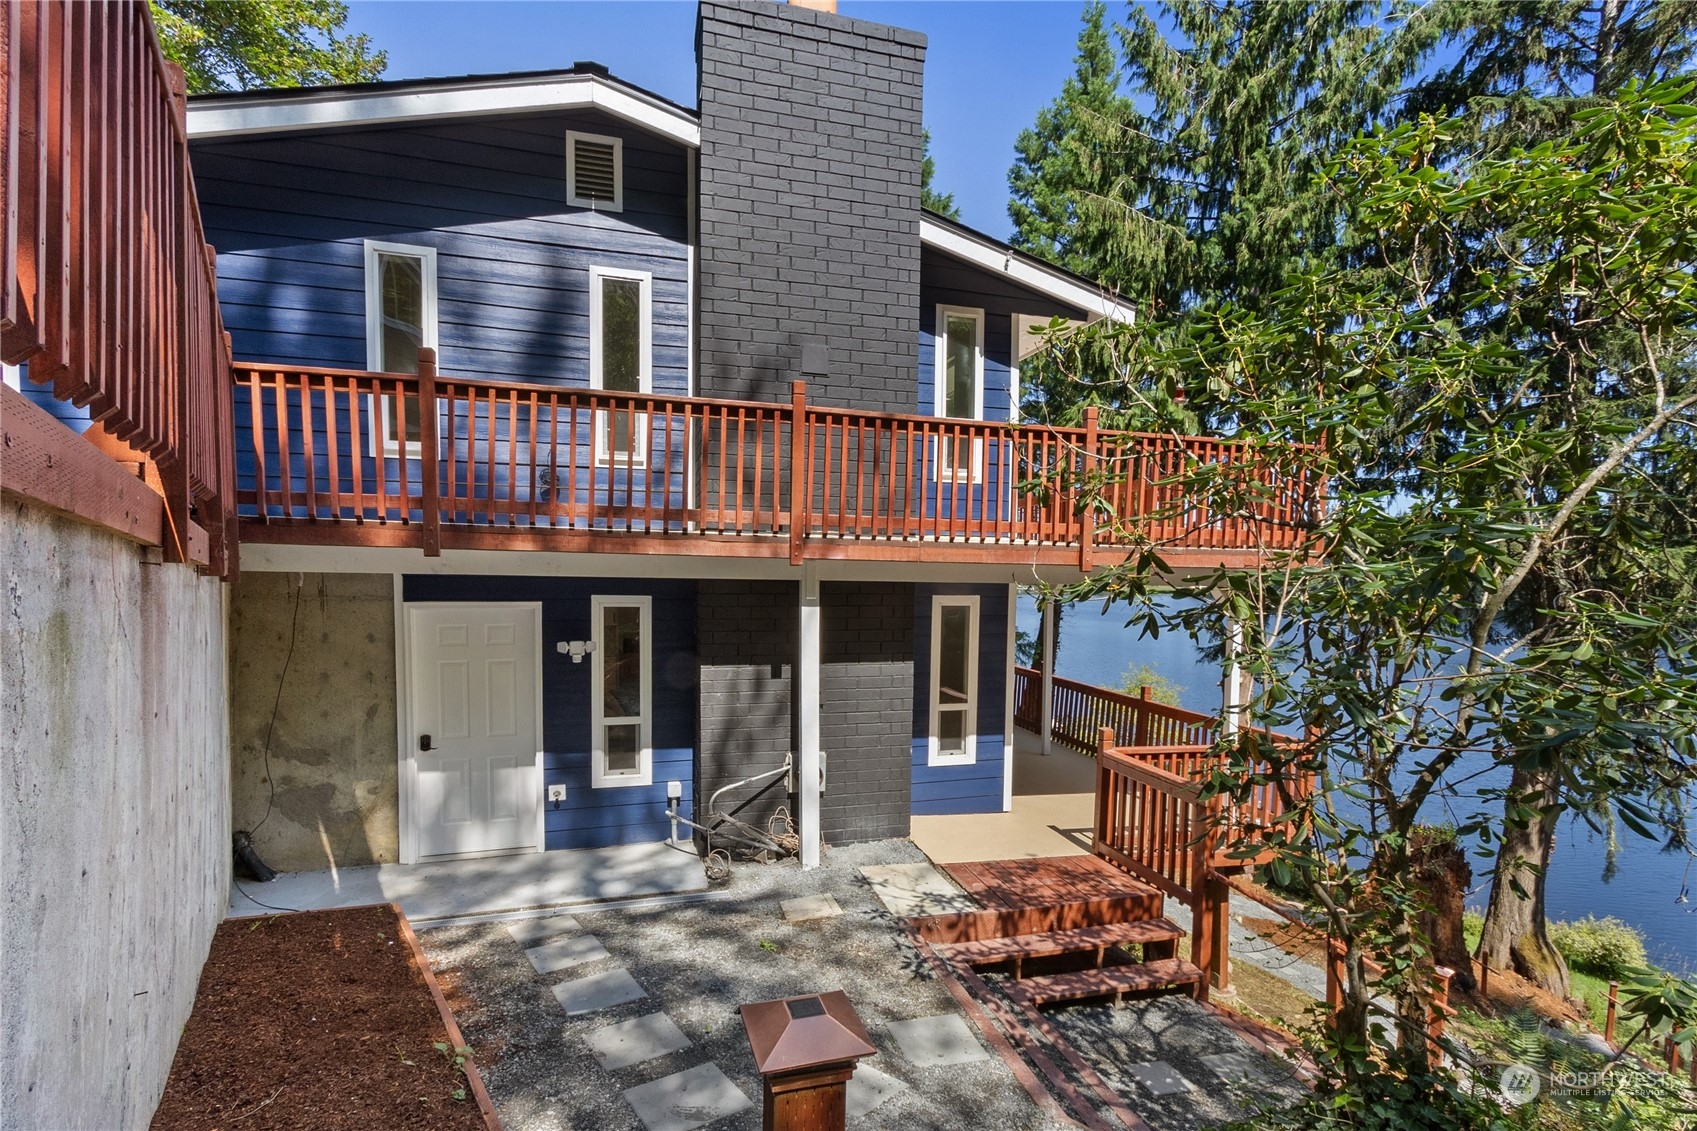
<box><xmin>348</xmin><ymin>0</ymin><xmax>1083</xmax><ymax>238</ymax></box>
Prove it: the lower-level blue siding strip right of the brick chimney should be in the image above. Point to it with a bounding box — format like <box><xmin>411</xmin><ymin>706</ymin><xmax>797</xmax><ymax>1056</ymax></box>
<box><xmin>913</xmin><ymin>584</ymin><xmax>1008</xmax><ymax>817</ymax></box>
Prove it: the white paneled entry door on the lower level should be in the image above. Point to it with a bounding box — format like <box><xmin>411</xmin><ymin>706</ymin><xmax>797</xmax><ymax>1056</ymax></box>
<box><xmin>407</xmin><ymin>605</ymin><xmax>541</xmax><ymax>856</ymax></box>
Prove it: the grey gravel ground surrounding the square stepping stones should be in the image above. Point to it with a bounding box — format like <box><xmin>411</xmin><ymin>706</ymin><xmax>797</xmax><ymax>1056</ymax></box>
<box><xmin>419</xmin><ymin>841</ymin><xmax>1065</xmax><ymax>1131</ymax></box>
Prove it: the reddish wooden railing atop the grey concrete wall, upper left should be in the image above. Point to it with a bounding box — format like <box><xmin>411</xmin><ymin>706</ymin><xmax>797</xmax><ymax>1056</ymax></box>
<box><xmin>0</xmin><ymin>0</ymin><xmax>236</xmax><ymax>574</ymax></box>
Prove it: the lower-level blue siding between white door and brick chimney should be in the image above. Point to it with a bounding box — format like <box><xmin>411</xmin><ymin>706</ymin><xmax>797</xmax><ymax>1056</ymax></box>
<box><xmin>400</xmin><ymin>576</ymin><xmax>697</xmax><ymax>849</ymax></box>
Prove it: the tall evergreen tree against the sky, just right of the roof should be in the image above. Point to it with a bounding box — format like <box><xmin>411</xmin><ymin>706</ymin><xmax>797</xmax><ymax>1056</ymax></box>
<box><xmin>1011</xmin><ymin>0</ymin><xmax>1432</xmax><ymax>316</ymax></box>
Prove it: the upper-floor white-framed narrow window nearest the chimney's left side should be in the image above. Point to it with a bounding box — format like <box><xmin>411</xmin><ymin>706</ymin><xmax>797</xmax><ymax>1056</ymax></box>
<box><xmin>589</xmin><ymin>267</ymin><xmax>653</xmax><ymax>465</ymax></box>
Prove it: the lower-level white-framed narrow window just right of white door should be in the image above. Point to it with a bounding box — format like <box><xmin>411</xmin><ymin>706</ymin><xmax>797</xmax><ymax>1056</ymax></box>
<box><xmin>589</xmin><ymin>596</ymin><xmax>653</xmax><ymax>790</ymax></box>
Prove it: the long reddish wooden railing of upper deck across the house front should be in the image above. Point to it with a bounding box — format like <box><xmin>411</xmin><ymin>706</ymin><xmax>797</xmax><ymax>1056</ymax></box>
<box><xmin>234</xmin><ymin>350</ymin><xmax>1312</xmax><ymax>564</ymax></box>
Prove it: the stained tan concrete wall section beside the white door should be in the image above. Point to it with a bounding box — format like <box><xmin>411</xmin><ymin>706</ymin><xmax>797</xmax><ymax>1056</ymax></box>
<box><xmin>229</xmin><ymin>572</ymin><xmax>400</xmax><ymax>869</ymax></box>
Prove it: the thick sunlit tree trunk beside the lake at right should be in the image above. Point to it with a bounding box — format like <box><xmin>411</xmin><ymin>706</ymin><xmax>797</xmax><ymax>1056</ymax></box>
<box><xmin>1478</xmin><ymin>769</ymin><xmax>1571</xmax><ymax>1000</ymax></box>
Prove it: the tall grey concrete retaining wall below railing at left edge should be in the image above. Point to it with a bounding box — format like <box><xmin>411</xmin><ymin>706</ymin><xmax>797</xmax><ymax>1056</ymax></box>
<box><xmin>0</xmin><ymin>499</ymin><xmax>231</xmax><ymax>1129</ymax></box>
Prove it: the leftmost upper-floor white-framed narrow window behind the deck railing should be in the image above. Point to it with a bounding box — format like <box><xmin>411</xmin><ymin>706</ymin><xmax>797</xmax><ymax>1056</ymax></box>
<box><xmin>365</xmin><ymin>239</ymin><xmax>436</xmax><ymax>457</ymax></box>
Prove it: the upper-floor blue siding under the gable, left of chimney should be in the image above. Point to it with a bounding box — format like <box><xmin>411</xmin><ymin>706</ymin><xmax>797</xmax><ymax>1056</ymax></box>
<box><xmin>193</xmin><ymin>112</ymin><xmax>691</xmax><ymax>502</ymax></box>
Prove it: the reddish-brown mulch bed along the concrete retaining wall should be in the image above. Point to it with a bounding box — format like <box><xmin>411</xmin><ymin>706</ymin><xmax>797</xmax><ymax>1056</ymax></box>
<box><xmin>153</xmin><ymin>907</ymin><xmax>487</xmax><ymax>1131</ymax></box>
